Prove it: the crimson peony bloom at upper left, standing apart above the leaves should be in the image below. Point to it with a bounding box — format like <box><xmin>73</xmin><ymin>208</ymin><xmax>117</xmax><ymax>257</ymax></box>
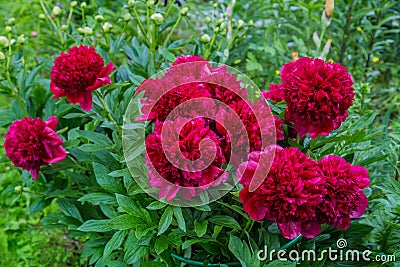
<box><xmin>50</xmin><ymin>45</ymin><xmax>114</xmax><ymax>110</ymax></box>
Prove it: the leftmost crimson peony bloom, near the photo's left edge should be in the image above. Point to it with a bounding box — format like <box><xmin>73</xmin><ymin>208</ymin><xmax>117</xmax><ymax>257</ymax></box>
<box><xmin>4</xmin><ymin>116</ymin><xmax>66</xmax><ymax>180</ymax></box>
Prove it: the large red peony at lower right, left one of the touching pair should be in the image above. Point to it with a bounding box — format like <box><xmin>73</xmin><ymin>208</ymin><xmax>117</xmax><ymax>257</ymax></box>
<box><xmin>237</xmin><ymin>146</ymin><xmax>325</xmax><ymax>239</ymax></box>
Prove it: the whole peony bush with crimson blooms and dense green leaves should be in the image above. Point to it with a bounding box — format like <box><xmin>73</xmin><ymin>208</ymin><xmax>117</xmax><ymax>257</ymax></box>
<box><xmin>0</xmin><ymin>1</ymin><xmax>384</xmax><ymax>267</ymax></box>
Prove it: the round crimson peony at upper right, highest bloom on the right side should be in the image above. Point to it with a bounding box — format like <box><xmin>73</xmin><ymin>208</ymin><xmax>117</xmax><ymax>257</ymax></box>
<box><xmin>263</xmin><ymin>57</ymin><xmax>354</xmax><ymax>139</ymax></box>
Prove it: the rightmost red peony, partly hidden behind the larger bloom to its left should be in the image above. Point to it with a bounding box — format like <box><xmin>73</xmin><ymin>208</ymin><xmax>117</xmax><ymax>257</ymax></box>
<box><xmin>317</xmin><ymin>155</ymin><xmax>369</xmax><ymax>230</ymax></box>
